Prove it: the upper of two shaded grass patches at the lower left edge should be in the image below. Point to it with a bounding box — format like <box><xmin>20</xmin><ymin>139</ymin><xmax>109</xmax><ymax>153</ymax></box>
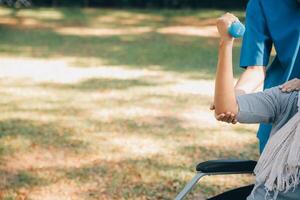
<box><xmin>0</xmin><ymin>119</ymin><xmax>88</xmax><ymax>152</ymax></box>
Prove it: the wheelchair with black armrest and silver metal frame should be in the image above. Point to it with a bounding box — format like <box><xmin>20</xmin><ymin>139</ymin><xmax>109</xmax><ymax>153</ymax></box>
<box><xmin>175</xmin><ymin>160</ymin><xmax>257</xmax><ymax>200</ymax></box>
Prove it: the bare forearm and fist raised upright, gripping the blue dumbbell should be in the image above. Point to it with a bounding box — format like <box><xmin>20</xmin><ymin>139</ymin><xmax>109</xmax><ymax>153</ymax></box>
<box><xmin>214</xmin><ymin>13</ymin><xmax>238</xmax><ymax>115</ymax></box>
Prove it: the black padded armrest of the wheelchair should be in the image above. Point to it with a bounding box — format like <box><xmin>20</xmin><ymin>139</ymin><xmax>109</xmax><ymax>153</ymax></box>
<box><xmin>196</xmin><ymin>160</ymin><xmax>257</xmax><ymax>174</ymax></box>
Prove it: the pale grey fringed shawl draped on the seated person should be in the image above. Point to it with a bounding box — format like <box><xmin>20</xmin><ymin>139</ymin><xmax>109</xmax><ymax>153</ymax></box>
<box><xmin>252</xmin><ymin>92</ymin><xmax>300</xmax><ymax>199</ymax></box>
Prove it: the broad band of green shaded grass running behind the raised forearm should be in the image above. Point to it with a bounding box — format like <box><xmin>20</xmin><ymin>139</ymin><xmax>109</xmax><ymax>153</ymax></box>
<box><xmin>0</xmin><ymin>21</ymin><xmax>241</xmax><ymax>79</ymax></box>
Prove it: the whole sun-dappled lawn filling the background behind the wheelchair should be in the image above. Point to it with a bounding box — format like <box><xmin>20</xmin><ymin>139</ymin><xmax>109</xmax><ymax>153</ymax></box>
<box><xmin>0</xmin><ymin>8</ymin><xmax>258</xmax><ymax>200</ymax></box>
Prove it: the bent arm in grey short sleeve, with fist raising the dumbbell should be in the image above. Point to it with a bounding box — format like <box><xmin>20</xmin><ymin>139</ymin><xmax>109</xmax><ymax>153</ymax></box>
<box><xmin>214</xmin><ymin>13</ymin><xmax>278</xmax><ymax>123</ymax></box>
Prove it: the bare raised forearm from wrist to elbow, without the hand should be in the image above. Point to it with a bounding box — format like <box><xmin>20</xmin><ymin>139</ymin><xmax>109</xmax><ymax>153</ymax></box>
<box><xmin>214</xmin><ymin>40</ymin><xmax>238</xmax><ymax>115</ymax></box>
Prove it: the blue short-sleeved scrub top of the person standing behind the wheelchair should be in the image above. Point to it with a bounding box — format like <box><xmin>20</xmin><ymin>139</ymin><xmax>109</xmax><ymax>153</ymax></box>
<box><xmin>240</xmin><ymin>0</ymin><xmax>300</xmax><ymax>152</ymax></box>
